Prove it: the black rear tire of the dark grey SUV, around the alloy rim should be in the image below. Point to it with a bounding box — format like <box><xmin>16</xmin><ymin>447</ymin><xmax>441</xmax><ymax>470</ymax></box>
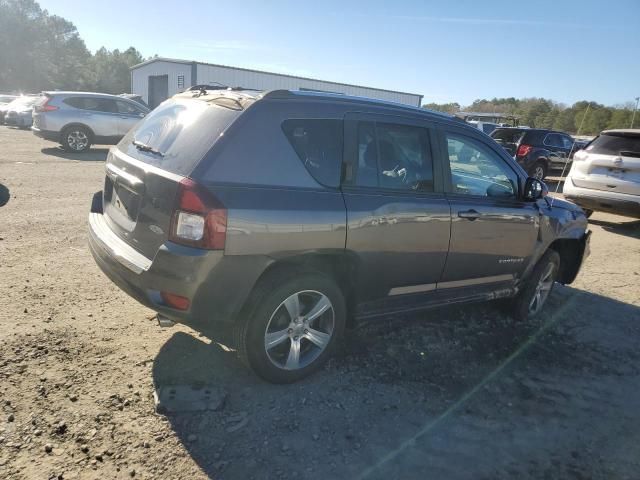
<box><xmin>234</xmin><ymin>270</ymin><xmax>346</xmax><ymax>383</ymax></box>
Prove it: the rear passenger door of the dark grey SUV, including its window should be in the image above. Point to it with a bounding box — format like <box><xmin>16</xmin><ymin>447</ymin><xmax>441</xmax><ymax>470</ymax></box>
<box><xmin>343</xmin><ymin>114</ymin><xmax>451</xmax><ymax>306</ymax></box>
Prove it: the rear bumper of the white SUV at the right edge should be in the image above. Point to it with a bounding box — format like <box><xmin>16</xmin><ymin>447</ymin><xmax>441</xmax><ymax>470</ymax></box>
<box><xmin>562</xmin><ymin>177</ymin><xmax>640</xmax><ymax>218</ymax></box>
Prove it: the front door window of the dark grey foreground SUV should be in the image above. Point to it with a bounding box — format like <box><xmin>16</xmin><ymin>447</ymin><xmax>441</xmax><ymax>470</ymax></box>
<box><xmin>447</xmin><ymin>133</ymin><xmax>518</xmax><ymax>198</ymax></box>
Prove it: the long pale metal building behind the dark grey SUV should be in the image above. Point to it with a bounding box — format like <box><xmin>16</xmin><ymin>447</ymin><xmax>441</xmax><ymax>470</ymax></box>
<box><xmin>131</xmin><ymin>58</ymin><xmax>422</xmax><ymax>108</ymax></box>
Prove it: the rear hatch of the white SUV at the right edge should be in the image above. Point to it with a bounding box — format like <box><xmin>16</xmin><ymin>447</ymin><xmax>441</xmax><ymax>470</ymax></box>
<box><xmin>571</xmin><ymin>130</ymin><xmax>640</xmax><ymax>195</ymax></box>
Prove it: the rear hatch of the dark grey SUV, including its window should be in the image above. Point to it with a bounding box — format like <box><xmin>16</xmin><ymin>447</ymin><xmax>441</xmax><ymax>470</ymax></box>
<box><xmin>103</xmin><ymin>94</ymin><xmax>249</xmax><ymax>258</ymax></box>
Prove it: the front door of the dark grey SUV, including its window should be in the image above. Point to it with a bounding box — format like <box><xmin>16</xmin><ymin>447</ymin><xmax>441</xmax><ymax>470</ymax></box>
<box><xmin>438</xmin><ymin>128</ymin><xmax>540</xmax><ymax>292</ymax></box>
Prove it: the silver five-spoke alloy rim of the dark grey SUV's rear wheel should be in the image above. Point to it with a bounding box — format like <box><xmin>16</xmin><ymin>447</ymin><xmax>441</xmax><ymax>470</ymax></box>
<box><xmin>264</xmin><ymin>290</ymin><xmax>335</xmax><ymax>370</ymax></box>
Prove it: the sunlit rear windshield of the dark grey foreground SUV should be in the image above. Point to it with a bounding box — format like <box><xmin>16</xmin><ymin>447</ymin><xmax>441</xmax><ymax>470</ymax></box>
<box><xmin>118</xmin><ymin>99</ymin><xmax>242</xmax><ymax>175</ymax></box>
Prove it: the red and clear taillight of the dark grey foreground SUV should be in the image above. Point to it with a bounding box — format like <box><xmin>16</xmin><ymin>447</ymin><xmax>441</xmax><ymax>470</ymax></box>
<box><xmin>169</xmin><ymin>178</ymin><xmax>227</xmax><ymax>250</ymax></box>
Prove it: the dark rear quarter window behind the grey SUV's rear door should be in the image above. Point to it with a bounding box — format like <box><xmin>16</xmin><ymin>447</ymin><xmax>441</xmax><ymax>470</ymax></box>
<box><xmin>282</xmin><ymin>119</ymin><xmax>343</xmax><ymax>187</ymax></box>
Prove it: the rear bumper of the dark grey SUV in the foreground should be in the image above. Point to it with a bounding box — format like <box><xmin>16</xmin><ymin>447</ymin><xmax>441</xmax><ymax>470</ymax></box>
<box><xmin>89</xmin><ymin>192</ymin><xmax>269</xmax><ymax>332</ymax></box>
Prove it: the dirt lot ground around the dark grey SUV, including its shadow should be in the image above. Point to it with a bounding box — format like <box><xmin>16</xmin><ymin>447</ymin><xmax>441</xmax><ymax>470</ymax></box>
<box><xmin>0</xmin><ymin>127</ymin><xmax>640</xmax><ymax>479</ymax></box>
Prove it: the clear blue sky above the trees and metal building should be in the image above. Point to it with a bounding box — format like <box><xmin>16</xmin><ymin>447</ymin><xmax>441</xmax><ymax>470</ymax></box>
<box><xmin>39</xmin><ymin>0</ymin><xmax>640</xmax><ymax>106</ymax></box>
